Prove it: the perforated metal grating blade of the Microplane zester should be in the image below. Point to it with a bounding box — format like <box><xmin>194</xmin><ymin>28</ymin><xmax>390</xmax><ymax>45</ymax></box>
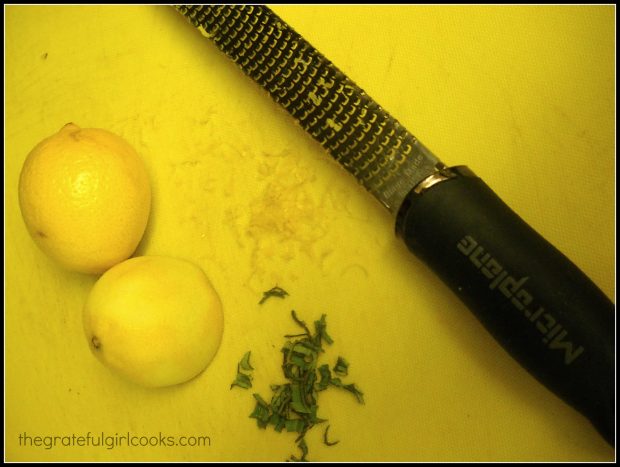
<box><xmin>176</xmin><ymin>5</ymin><xmax>444</xmax><ymax>215</ymax></box>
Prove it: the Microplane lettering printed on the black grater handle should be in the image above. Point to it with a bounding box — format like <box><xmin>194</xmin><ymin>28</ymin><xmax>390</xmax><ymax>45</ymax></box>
<box><xmin>457</xmin><ymin>235</ymin><xmax>584</xmax><ymax>365</ymax></box>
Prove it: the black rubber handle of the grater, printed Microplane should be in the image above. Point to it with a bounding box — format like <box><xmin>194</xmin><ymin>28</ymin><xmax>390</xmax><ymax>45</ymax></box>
<box><xmin>397</xmin><ymin>168</ymin><xmax>615</xmax><ymax>446</ymax></box>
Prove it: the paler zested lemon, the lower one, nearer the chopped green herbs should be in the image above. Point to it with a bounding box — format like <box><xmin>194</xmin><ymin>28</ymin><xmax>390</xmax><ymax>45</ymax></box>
<box><xmin>84</xmin><ymin>256</ymin><xmax>223</xmax><ymax>387</ymax></box>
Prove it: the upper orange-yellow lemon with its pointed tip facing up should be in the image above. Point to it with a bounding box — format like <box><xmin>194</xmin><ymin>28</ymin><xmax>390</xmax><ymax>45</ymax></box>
<box><xmin>19</xmin><ymin>123</ymin><xmax>151</xmax><ymax>274</ymax></box>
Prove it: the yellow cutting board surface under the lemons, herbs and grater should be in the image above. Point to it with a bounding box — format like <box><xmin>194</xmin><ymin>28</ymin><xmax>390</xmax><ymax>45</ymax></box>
<box><xmin>5</xmin><ymin>5</ymin><xmax>615</xmax><ymax>461</ymax></box>
